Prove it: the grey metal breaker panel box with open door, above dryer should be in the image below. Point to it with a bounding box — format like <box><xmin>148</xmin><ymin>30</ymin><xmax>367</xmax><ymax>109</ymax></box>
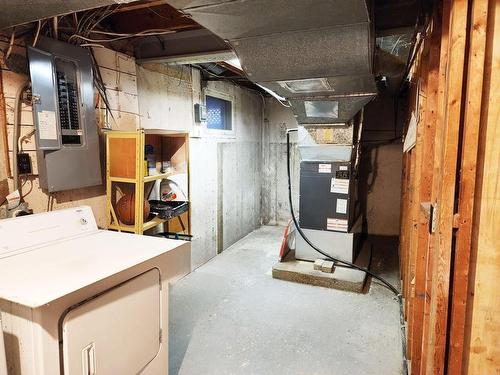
<box><xmin>28</xmin><ymin>38</ymin><xmax>102</xmax><ymax>192</ymax></box>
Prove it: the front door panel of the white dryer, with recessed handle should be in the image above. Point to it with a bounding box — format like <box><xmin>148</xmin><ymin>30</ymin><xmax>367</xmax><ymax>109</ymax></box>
<box><xmin>62</xmin><ymin>268</ymin><xmax>162</xmax><ymax>375</ymax></box>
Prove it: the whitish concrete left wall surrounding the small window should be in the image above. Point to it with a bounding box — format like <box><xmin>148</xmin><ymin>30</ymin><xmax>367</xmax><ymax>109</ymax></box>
<box><xmin>138</xmin><ymin>64</ymin><xmax>262</xmax><ymax>268</ymax></box>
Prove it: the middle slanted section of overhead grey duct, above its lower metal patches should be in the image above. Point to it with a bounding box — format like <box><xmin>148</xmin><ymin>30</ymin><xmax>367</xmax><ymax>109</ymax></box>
<box><xmin>230</xmin><ymin>23</ymin><xmax>372</xmax><ymax>82</ymax></box>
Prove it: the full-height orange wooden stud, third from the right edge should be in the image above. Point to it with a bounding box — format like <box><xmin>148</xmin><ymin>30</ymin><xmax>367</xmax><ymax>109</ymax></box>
<box><xmin>426</xmin><ymin>0</ymin><xmax>468</xmax><ymax>374</ymax></box>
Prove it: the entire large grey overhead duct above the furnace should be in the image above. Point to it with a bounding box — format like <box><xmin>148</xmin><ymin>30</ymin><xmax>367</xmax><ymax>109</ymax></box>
<box><xmin>169</xmin><ymin>0</ymin><xmax>377</xmax><ymax>124</ymax></box>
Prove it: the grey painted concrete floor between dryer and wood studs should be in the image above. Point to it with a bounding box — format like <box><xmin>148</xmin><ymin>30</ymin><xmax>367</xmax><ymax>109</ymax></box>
<box><xmin>169</xmin><ymin>227</ymin><xmax>402</xmax><ymax>375</ymax></box>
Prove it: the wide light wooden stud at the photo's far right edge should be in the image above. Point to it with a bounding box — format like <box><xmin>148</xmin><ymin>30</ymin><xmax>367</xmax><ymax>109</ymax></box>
<box><xmin>463</xmin><ymin>0</ymin><xmax>500</xmax><ymax>375</ymax></box>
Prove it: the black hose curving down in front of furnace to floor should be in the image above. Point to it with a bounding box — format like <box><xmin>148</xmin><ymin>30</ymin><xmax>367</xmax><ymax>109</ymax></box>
<box><xmin>286</xmin><ymin>129</ymin><xmax>401</xmax><ymax>300</ymax></box>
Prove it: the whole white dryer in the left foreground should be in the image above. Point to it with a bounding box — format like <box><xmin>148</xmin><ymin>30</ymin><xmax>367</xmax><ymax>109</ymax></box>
<box><xmin>0</xmin><ymin>207</ymin><xmax>191</xmax><ymax>375</ymax></box>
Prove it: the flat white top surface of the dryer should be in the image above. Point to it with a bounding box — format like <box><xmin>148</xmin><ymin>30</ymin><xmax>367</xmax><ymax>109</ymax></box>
<box><xmin>0</xmin><ymin>229</ymin><xmax>189</xmax><ymax>308</ymax></box>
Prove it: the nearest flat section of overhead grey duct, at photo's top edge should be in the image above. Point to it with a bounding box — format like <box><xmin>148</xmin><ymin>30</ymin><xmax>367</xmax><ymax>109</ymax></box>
<box><xmin>168</xmin><ymin>0</ymin><xmax>369</xmax><ymax>40</ymax></box>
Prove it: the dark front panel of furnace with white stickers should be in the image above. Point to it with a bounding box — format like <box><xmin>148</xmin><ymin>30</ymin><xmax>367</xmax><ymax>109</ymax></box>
<box><xmin>299</xmin><ymin>161</ymin><xmax>355</xmax><ymax>232</ymax></box>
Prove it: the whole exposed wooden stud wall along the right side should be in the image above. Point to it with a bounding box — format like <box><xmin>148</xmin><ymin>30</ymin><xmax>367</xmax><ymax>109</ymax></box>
<box><xmin>400</xmin><ymin>0</ymin><xmax>500</xmax><ymax>375</ymax></box>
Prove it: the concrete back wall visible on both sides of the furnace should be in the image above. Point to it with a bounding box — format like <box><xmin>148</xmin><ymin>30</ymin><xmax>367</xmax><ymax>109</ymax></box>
<box><xmin>262</xmin><ymin>96</ymin><xmax>402</xmax><ymax>236</ymax></box>
